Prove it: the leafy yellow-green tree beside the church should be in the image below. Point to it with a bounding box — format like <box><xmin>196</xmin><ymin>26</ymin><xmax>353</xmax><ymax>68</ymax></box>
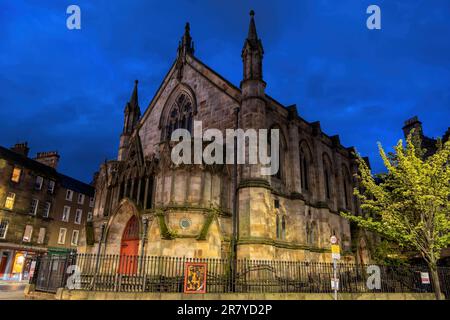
<box><xmin>341</xmin><ymin>135</ymin><xmax>450</xmax><ymax>299</ymax></box>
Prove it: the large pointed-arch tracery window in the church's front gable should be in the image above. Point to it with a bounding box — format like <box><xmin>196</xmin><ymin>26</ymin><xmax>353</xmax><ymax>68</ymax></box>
<box><xmin>165</xmin><ymin>93</ymin><xmax>193</xmax><ymax>140</ymax></box>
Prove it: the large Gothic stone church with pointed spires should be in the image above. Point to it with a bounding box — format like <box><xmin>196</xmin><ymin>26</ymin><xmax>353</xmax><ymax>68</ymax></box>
<box><xmin>81</xmin><ymin>12</ymin><xmax>368</xmax><ymax>261</ymax></box>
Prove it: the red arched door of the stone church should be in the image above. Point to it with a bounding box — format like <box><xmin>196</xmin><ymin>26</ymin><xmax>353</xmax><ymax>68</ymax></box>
<box><xmin>119</xmin><ymin>216</ymin><xmax>139</xmax><ymax>274</ymax></box>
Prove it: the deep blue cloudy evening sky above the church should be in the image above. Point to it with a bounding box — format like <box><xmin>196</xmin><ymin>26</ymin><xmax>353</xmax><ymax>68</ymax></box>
<box><xmin>0</xmin><ymin>0</ymin><xmax>450</xmax><ymax>182</ymax></box>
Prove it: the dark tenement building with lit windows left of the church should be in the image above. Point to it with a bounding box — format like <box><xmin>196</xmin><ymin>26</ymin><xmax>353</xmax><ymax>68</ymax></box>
<box><xmin>0</xmin><ymin>143</ymin><xmax>94</xmax><ymax>279</ymax></box>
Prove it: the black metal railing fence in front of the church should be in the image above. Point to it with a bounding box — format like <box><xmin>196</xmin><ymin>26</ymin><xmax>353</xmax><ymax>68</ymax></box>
<box><xmin>31</xmin><ymin>254</ymin><xmax>450</xmax><ymax>297</ymax></box>
